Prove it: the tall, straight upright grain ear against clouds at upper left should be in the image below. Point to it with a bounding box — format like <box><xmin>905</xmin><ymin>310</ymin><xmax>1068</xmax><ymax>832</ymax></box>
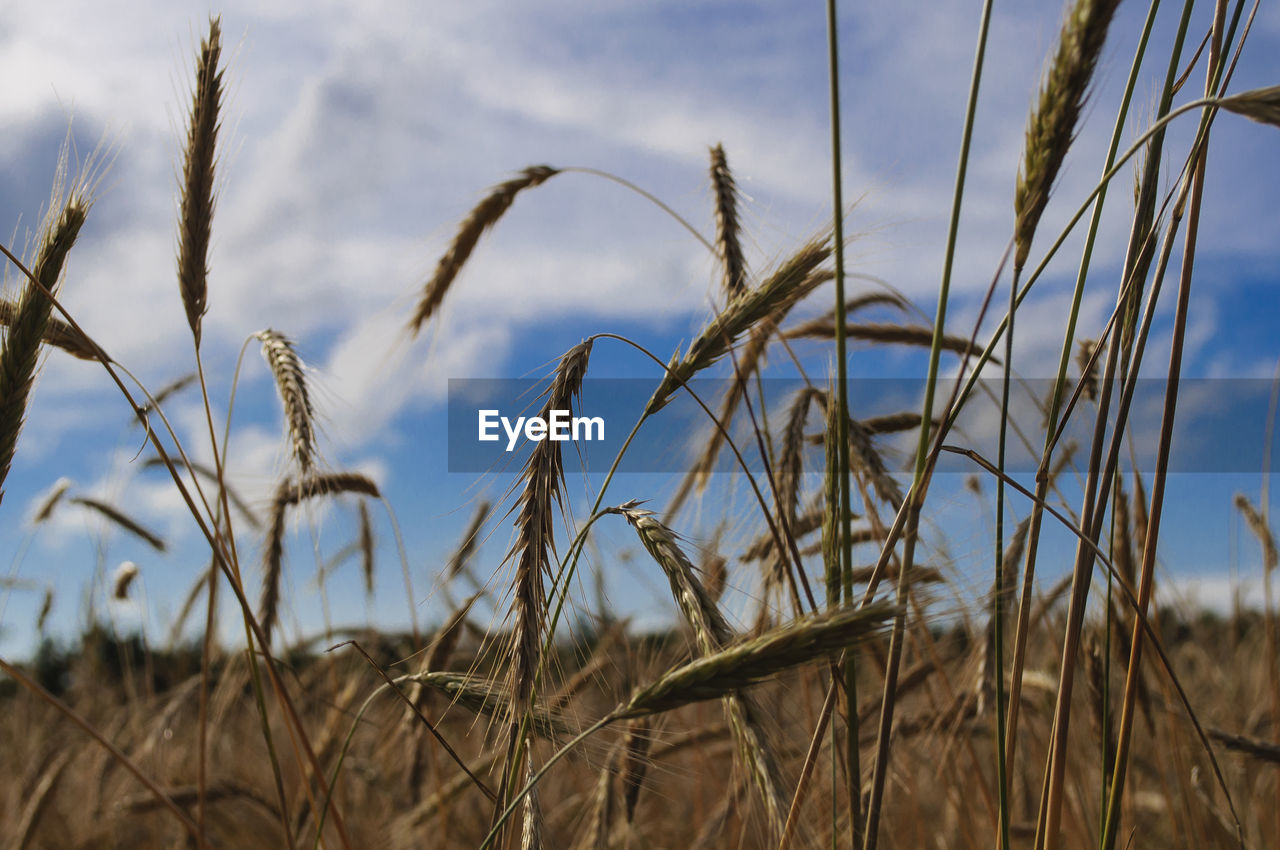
<box><xmin>178</xmin><ymin>18</ymin><xmax>223</xmax><ymax>348</ymax></box>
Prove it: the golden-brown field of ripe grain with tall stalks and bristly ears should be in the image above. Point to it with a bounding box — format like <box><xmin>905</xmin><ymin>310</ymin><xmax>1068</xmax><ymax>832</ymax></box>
<box><xmin>0</xmin><ymin>6</ymin><xmax>1280</xmax><ymax>850</ymax></box>
